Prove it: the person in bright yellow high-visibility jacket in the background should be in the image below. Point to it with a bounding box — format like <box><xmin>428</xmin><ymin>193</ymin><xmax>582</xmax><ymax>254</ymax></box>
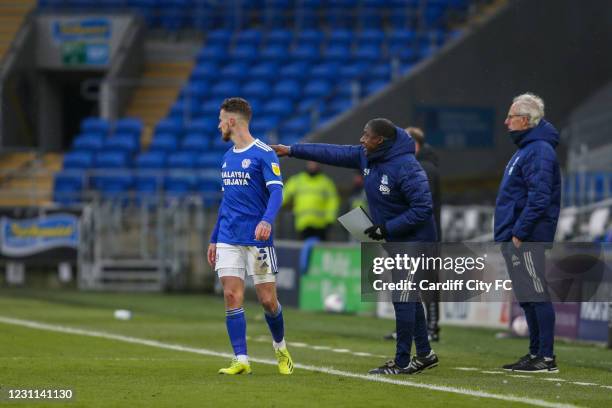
<box><xmin>283</xmin><ymin>161</ymin><xmax>340</xmax><ymax>241</ymax></box>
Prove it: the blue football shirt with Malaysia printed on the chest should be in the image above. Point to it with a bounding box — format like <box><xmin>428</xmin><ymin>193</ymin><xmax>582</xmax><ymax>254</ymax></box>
<box><xmin>217</xmin><ymin>139</ymin><xmax>283</xmax><ymax>247</ymax></box>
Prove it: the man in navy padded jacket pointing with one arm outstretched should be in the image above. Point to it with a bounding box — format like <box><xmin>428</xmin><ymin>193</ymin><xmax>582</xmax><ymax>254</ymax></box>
<box><xmin>271</xmin><ymin>118</ymin><xmax>438</xmax><ymax>374</ymax></box>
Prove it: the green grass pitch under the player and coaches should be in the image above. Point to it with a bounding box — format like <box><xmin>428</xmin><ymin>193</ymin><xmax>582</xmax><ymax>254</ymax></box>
<box><xmin>0</xmin><ymin>290</ymin><xmax>612</xmax><ymax>407</ymax></box>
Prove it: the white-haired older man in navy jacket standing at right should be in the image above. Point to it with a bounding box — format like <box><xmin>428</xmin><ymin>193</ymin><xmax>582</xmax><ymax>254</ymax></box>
<box><xmin>495</xmin><ymin>93</ymin><xmax>561</xmax><ymax>372</ymax></box>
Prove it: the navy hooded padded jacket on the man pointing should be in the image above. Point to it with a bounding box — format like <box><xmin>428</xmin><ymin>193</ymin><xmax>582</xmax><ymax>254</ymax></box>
<box><xmin>291</xmin><ymin>127</ymin><xmax>436</xmax><ymax>242</ymax></box>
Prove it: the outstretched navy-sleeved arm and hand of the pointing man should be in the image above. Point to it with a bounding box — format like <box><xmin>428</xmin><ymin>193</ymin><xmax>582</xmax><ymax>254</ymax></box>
<box><xmin>270</xmin><ymin>143</ymin><xmax>365</xmax><ymax>169</ymax></box>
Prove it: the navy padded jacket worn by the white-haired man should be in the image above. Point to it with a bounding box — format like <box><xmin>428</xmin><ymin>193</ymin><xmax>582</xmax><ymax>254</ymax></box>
<box><xmin>495</xmin><ymin>119</ymin><xmax>561</xmax><ymax>242</ymax></box>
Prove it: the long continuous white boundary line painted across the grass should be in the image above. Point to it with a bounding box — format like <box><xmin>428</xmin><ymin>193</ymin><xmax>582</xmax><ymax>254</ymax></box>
<box><xmin>0</xmin><ymin>316</ymin><xmax>576</xmax><ymax>408</ymax></box>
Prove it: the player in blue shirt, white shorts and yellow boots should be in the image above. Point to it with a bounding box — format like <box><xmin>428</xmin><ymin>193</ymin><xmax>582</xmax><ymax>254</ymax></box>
<box><xmin>208</xmin><ymin>98</ymin><xmax>293</xmax><ymax>375</ymax></box>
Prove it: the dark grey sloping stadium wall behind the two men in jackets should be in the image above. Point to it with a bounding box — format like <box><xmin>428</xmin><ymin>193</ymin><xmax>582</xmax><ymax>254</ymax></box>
<box><xmin>296</xmin><ymin>0</ymin><xmax>612</xmax><ymax>193</ymax></box>
